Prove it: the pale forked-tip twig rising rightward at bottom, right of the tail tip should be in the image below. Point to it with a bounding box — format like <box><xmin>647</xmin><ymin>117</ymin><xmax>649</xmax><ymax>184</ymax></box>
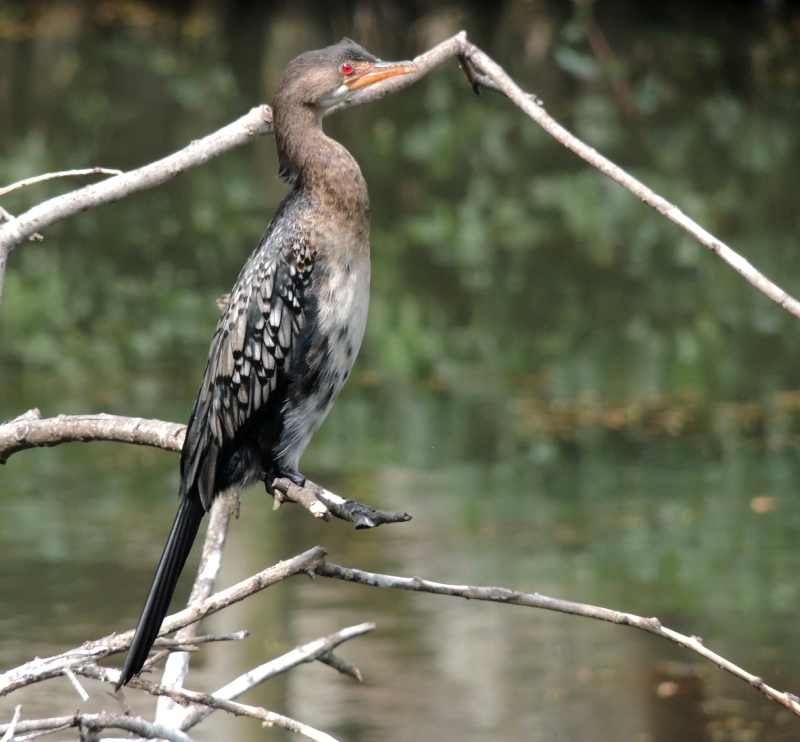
<box><xmin>180</xmin><ymin>623</ymin><xmax>375</xmax><ymax>731</ymax></box>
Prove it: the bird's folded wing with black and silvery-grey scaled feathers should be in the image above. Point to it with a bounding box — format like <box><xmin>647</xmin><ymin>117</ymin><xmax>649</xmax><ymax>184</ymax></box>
<box><xmin>181</xmin><ymin>229</ymin><xmax>313</xmax><ymax>509</ymax></box>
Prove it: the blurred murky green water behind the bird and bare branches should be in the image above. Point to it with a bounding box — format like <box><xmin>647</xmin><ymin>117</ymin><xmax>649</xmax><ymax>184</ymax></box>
<box><xmin>0</xmin><ymin>2</ymin><xmax>800</xmax><ymax>742</ymax></box>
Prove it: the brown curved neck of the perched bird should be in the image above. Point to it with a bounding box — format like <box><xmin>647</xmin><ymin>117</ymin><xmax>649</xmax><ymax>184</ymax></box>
<box><xmin>273</xmin><ymin>105</ymin><xmax>369</xmax><ymax>218</ymax></box>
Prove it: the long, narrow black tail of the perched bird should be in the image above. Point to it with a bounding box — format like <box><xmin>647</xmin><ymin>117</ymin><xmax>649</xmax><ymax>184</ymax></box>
<box><xmin>117</xmin><ymin>492</ymin><xmax>205</xmax><ymax>689</ymax></box>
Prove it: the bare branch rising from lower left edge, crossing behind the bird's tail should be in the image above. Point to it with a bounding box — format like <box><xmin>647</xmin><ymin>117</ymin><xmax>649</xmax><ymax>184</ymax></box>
<box><xmin>0</xmin><ymin>546</ymin><xmax>325</xmax><ymax>697</ymax></box>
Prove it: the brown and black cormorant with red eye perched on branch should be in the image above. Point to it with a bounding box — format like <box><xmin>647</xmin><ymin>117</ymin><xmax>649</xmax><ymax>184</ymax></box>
<box><xmin>117</xmin><ymin>38</ymin><xmax>416</xmax><ymax>689</ymax></box>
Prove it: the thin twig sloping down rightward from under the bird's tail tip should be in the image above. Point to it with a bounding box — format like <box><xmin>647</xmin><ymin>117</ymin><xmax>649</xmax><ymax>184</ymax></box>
<box><xmin>78</xmin><ymin>665</ymin><xmax>338</xmax><ymax>742</ymax></box>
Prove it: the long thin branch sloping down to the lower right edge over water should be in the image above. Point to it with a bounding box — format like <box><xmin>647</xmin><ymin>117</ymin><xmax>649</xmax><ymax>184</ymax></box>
<box><xmin>314</xmin><ymin>561</ymin><xmax>800</xmax><ymax>716</ymax></box>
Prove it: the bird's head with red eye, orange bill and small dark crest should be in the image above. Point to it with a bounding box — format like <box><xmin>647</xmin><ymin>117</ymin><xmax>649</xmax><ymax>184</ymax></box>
<box><xmin>275</xmin><ymin>38</ymin><xmax>417</xmax><ymax>115</ymax></box>
